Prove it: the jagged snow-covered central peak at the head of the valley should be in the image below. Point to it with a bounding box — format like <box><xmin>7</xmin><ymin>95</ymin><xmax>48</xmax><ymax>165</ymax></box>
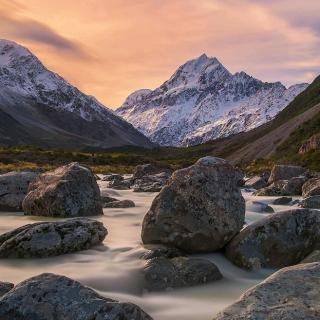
<box><xmin>116</xmin><ymin>54</ymin><xmax>307</xmax><ymax>146</ymax></box>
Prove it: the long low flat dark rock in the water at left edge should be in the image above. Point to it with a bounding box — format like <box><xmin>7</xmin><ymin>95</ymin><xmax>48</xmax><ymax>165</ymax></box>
<box><xmin>0</xmin><ymin>218</ymin><xmax>108</xmax><ymax>258</ymax></box>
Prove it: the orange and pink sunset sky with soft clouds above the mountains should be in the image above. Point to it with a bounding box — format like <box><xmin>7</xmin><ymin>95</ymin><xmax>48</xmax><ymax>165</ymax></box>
<box><xmin>0</xmin><ymin>0</ymin><xmax>320</xmax><ymax>109</ymax></box>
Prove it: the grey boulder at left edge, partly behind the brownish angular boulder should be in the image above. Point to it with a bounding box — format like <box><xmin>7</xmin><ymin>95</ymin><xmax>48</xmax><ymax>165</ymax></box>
<box><xmin>0</xmin><ymin>171</ymin><xmax>38</xmax><ymax>211</ymax></box>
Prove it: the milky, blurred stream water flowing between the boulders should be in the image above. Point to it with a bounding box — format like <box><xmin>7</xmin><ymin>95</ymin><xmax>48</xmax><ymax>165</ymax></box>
<box><xmin>0</xmin><ymin>181</ymin><xmax>300</xmax><ymax>320</ymax></box>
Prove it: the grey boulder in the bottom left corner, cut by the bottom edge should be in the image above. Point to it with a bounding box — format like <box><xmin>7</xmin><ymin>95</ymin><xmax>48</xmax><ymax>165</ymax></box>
<box><xmin>0</xmin><ymin>273</ymin><xmax>152</xmax><ymax>320</ymax></box>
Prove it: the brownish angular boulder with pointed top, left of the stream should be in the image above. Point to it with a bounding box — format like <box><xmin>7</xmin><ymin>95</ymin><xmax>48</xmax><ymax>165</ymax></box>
<box><xmin>22</xmin><ymin>162</ymin><xmax>103</xmax><ymax>217</ymax></box>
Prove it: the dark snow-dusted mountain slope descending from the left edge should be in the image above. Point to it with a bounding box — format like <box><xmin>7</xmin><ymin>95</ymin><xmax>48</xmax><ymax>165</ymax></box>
<box><xmin>0</xmin><ymin>40</ymin><xmax>153</xmax><ymax>149</ymax></box>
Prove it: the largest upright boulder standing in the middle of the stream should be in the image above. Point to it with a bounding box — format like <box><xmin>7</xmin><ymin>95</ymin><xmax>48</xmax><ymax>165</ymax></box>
<box><xmin>141</xmin><ymin>157</ymin><xmax>245</xmax><ymax>252</ymax></box>
